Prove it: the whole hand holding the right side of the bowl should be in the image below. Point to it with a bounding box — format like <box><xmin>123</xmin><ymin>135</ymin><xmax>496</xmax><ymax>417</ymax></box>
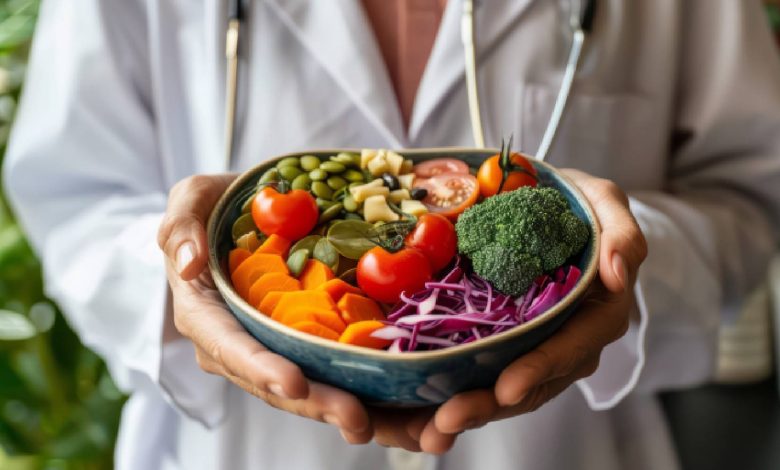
<box><xmin>345</xmin><ymin>170</ymin><xmax>647</xmax><ymax>454</ymax></box>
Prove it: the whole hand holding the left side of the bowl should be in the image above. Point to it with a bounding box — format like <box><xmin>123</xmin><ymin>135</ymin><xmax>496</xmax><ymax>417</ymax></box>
<box><xmin>158</xmin><ymin>175</ymin><xmax>372</xmax><ymax>443</ymax></box>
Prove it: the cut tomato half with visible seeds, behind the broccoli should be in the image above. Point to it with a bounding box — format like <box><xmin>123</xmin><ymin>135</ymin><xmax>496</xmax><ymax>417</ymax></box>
<box><xmin>417</xmin><ymin>173</ymin><xmax>479</xmax><ymax>221</ymax></box>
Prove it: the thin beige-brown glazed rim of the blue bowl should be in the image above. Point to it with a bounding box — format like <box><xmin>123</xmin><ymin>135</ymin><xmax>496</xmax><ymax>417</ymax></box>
<box><xmin>206</xmin><ymin>147</ymin><xmax>601</xmax><ymax>362</ymax></box>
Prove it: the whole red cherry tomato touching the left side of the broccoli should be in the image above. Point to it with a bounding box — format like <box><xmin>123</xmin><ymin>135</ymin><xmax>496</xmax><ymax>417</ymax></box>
<box><xmin>406</xmin><ymin>213</ymin><xmax>458</xmax><ymax>272</ymax></box>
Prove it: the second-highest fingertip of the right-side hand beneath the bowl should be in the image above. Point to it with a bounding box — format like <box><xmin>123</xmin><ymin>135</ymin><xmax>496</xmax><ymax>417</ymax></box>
<box><xmin>435</xmin><ymin>390</ymin><xmax>499</xmax><ymax>434</ymax></box>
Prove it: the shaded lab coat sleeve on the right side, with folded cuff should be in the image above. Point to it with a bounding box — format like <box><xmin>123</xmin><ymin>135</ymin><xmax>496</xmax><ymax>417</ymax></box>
<box><xmin>578</xmin><ymin>0</ymin><xmax>780</xmax><ymax>409</ymax></box>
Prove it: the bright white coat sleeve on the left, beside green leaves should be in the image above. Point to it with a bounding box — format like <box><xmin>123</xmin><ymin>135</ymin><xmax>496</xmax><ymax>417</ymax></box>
<box><xmin>4</xmin><ymin>0</ymin><xmax>224</xmax><ymax>424</ymax></box>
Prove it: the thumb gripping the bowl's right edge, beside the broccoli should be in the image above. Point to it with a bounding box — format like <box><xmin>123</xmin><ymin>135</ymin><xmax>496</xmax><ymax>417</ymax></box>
<box><xmin>564</xmin><ymin>170</ymin><xmax>647</xmax><ymax>292</ymax></box>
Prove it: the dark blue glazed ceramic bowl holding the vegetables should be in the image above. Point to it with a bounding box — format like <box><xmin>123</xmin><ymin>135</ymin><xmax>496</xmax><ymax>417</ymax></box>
<box><xmin>208</xmin><ymin>149</ymin><xmax>600</xmax><ymax>407</ymax></box>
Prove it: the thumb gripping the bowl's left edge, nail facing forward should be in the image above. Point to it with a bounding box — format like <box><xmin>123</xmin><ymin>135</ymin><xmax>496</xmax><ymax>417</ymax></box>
<box><xmin>157</xmin><ymin>175</ymin><xmax>236</xmax><ymax>280</ymax></box>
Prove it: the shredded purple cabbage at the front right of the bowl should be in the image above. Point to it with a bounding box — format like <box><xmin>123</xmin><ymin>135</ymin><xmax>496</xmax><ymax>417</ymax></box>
<box><xmin>372</xmin><ymin>259</ymin><xmax>581</xmax><ymax>352</ymax></box>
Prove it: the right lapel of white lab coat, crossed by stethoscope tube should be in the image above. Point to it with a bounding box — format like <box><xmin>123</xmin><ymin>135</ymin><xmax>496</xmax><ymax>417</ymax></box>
<box><xmin>409</xmin><ymin>0</ymin><xmax>535</xmax><ymax>143</ymax></box>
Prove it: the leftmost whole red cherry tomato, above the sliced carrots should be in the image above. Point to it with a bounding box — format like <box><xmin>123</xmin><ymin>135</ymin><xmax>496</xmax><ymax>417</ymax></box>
<box><xmin>252</xmin><ymin>186</ymin><xmax>320</xmax><ymax>241</ymax></box>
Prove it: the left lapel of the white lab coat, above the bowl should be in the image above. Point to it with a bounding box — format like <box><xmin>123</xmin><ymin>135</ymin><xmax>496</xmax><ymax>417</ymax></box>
<box><xmin>267</xmin><ymin>0</ymin><xmax>406</xmax><ymax>148</ymax></box>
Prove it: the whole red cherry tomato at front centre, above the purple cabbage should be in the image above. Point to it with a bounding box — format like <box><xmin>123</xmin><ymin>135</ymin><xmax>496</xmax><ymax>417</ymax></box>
<box><xmin>357</xmin><ymin>246</ymin><xmax>432</xmax><ymax>304</ymax></box>
